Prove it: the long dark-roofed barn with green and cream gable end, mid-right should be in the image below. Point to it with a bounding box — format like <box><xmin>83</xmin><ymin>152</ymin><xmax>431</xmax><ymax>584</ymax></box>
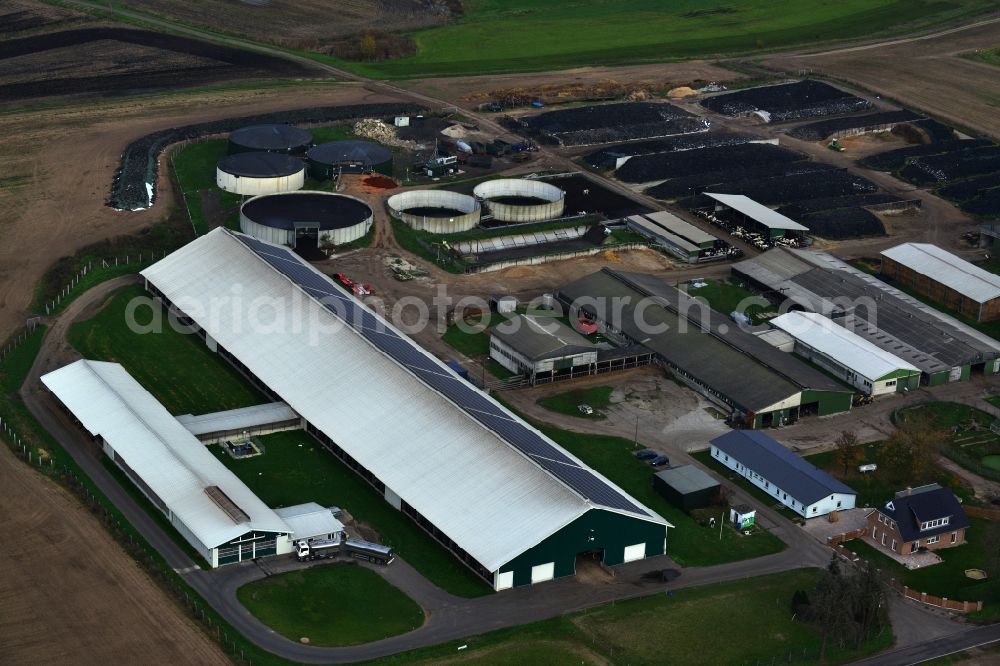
<box><xmin>558</xmin><ymin>268</ymin><xmax>854</xmax><ymax>428</ymax></box>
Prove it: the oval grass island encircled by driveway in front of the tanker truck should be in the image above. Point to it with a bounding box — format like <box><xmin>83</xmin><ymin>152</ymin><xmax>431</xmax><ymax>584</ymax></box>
<box><xmin>236</xmin><ymin>563</ymin><xmax>424</xmax><ymax>645</ymax></box>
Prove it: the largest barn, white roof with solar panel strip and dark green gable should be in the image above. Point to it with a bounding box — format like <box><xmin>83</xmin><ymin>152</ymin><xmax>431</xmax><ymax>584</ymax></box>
<box><xmin>142</xmin><ymin>228</ymin><xmax>670</xmax><ymax>590</ymax></box>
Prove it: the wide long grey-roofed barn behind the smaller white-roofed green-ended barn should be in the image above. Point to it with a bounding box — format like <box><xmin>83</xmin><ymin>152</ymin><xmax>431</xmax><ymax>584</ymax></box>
<box><xmin>732</xmin><ymin>247</ymin><xmax>1000</xmax><ymax>386</ymax></box>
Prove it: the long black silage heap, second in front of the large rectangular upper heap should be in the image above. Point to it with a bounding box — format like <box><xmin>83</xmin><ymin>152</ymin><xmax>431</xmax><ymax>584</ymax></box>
<box><xmin>615</xmin><ymin>143</ymin><xmax>806</xmax><ymax>183</ymax></box>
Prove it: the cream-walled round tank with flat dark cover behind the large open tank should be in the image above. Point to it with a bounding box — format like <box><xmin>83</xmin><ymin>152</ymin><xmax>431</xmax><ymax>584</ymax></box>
<box><xmin>215</xmin><ymin>152</ymin><xmax>306</xmax><ymax>196</ymax></box>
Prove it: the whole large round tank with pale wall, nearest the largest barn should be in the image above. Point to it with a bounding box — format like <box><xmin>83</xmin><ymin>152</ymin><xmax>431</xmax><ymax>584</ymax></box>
<box><xmin>240</xmin><ymin>190</ymin><xmax>373</xmax><ymax>247</ymax></box>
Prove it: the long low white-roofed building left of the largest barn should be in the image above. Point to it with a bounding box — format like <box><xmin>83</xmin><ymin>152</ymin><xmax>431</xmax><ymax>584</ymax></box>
<box><xmin>42</xmin><ymin>360</ymin><xmax>292</xmax><ymax>567</ymax></box>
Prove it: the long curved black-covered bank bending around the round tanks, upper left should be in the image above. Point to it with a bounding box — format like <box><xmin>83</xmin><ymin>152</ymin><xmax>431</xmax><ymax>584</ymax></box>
<box><xmin>108</xmin><ymin>104</ymin><xmax>423</xmax><ymax>210</ymax></box>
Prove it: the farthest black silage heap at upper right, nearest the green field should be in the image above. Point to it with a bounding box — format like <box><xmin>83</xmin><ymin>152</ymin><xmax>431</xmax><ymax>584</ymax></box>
<box><xmin>701</xmin><ymin>80</ymin><xmax>872</xmax><ymax>123</ymax></box>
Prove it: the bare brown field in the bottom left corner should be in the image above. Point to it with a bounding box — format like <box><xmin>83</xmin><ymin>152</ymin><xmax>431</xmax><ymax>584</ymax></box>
<box><xmin>0</xmin><ymin>446</ymin><xmax>230</xmax><ymax>666</ymax></box>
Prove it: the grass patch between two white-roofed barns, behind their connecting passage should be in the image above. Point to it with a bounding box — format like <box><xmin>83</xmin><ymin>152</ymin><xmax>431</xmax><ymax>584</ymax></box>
<box><xmin>68</xmin><ymin>285</ymin><xmax>269</xmax><ymax>414</ymax></box>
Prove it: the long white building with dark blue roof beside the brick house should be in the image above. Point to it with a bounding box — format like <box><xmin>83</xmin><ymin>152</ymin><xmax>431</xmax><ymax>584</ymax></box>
<box><xmin>711</xmin><ymin>430</ymin><xmax>857</xmax><ymax>518</ymax></box>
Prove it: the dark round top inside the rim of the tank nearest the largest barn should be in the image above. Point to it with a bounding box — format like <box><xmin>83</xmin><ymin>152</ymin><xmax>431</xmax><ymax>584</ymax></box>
<box><xmin>241</xmin><ymin>192</ymin><xmax>372</xmax><ymax>230</ymax></box>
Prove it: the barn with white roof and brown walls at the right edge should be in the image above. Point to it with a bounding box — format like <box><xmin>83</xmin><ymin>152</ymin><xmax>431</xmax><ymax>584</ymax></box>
<box><xmin>881</xmin><ymin>243</ymin><xmax>1000</xmax><ymax>321</ymax></box>
